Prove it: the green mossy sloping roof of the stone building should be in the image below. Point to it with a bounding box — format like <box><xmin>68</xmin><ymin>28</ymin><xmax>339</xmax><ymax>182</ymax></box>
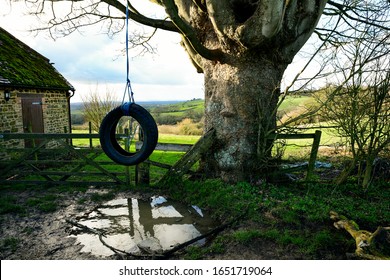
<box><xmin>0</xmin><ymin>27</ymin><xmax>73</xmax><ymax>90</ymax></box>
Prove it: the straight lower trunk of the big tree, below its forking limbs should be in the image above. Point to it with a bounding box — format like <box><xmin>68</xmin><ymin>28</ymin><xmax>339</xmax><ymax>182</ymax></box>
<box><xmin>201</xmin><ymin>53</ymin><xmax>287</xmax><ymax>182</ymax></box>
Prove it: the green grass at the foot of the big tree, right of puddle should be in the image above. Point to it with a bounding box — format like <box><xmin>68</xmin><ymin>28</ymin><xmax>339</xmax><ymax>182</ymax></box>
<box><xmin>164</xmin><ymin>180</ymin><xmax>390</xmax><ymax>259</ymax></box>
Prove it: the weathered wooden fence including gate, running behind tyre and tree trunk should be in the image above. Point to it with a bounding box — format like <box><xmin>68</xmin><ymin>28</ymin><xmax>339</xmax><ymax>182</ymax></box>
<box><xmin>0</xmin><ymin>131</ymin><xmax>321</xmax><ymax>186</ymax></box>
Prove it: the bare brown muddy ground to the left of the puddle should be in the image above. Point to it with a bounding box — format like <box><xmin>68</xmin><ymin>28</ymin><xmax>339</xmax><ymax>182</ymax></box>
<box><xmin>0</xmin><ymin>186</ymin><xmax>106</xmax><ymax>260</ymax></box>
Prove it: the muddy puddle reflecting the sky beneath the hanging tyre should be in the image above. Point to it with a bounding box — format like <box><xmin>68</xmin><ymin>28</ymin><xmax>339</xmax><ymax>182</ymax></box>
<box><xmin>71</xmin><ymin>196</ymin><xmax>217</xmax><ymax>256</ymax></box>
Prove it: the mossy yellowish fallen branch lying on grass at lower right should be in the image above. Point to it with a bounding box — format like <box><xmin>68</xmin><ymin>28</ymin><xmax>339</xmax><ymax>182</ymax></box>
<box><xmin>330</xmin><ymin>211</ymin><xmax>390</xmax><ymax>260</ymax></box>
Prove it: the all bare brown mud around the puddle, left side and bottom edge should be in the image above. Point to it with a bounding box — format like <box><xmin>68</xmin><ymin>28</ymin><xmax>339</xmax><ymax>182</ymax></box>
<box><xmin>0</xmin><ymin>187</ymin><xmax>294</xmax><ymax>260</ymax></box>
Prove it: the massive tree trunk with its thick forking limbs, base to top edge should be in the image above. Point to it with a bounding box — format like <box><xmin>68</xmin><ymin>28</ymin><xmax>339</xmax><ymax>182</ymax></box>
<box><xmin>160</xmin><ymin>0</ymin><xmax>326</xmax><ymax>182</ymax></box>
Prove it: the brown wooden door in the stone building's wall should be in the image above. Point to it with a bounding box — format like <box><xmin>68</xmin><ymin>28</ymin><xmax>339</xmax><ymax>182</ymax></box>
<box><xmin>21</xmin><ymin>95</ymin><xmax>44</xmax><ymax>148</ymax></box>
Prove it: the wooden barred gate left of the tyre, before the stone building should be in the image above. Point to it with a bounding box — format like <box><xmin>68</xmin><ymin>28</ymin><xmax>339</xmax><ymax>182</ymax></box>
<box><xmin>0</xmin><ymin>133</ymin><xmax>130</xmax><ymax>186</ymax></box>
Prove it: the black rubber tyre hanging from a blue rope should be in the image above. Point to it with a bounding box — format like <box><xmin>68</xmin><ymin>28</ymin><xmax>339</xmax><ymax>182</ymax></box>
<box><xmin>99</xmin><ymin>103</ymin><xmax>158</xmax><ymax>166</ymax></box>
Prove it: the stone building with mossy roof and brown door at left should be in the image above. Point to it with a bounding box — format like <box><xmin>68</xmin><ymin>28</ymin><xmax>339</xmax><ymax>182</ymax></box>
<box><xmin>0</xmin><ymin>27</ymin><xmax>75</xmax><ymax>149</ymax></box>
